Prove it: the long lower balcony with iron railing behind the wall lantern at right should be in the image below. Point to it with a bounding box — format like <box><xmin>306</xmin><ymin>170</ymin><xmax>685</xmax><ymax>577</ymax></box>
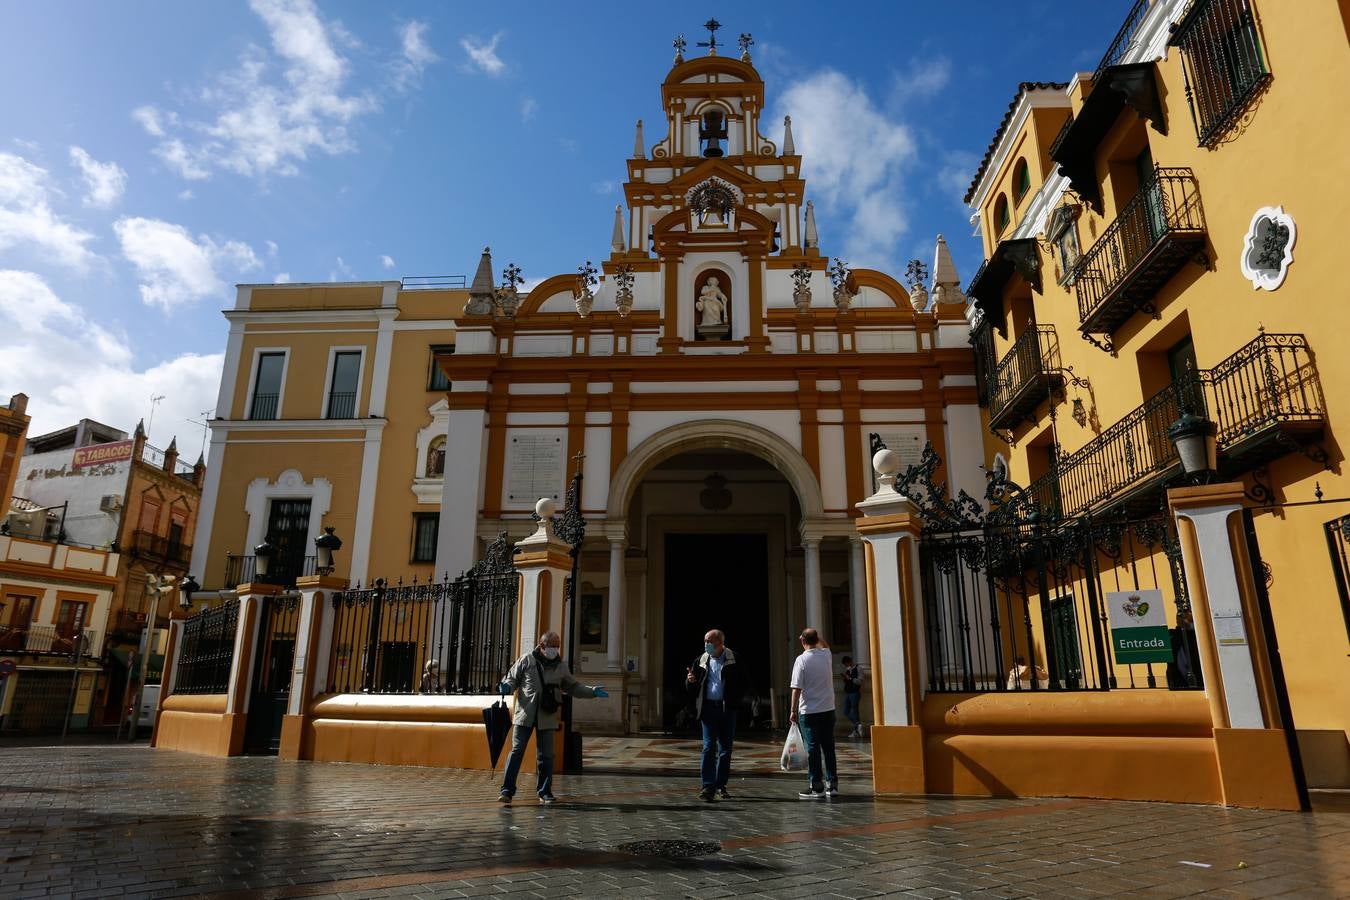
<box><xmin>1026</xmin><ymin>333</ymin><xmax>1326</xmax><ymax>517</ymax></box>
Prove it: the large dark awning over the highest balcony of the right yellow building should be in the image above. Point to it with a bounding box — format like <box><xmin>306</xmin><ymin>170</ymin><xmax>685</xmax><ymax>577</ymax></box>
<box><xmin>1050</xmin><ymin>62</ymin><xmax>1168</xmax><ymax>212</ymax></box>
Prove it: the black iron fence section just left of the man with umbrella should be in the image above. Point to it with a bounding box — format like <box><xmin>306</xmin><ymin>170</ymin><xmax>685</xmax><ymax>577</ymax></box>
<box><xmin>328</xmin><ymin>533</ymin><xmax>520</xmax><ymax>694</ymax></box>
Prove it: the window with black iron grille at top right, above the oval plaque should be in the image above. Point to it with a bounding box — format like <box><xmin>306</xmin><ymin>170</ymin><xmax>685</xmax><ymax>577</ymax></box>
<box><xmin>1170</xmin><ymin>0</ymin><xmax>1270</xmax><ymax>147</ymax></box>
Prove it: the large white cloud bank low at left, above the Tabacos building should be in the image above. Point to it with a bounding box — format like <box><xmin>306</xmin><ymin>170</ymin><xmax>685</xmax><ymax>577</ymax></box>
<box><xmin>0</xmin><ymin>270</ymin><xmax>223</xmax><ymax>447</ymax></box>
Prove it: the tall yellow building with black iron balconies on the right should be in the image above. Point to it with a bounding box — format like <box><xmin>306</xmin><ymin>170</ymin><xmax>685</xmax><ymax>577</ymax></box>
<box><xmin>965</xmin><ymin>0</ymin><xmax>1350</xmax><ymax>787</ymax></box>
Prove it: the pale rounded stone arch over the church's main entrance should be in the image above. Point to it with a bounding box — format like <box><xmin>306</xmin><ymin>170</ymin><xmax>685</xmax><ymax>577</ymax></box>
<box><xmin>605</xmin><ymin>418</ymin><xmax>825</xmax><ymax>522</ymax></box>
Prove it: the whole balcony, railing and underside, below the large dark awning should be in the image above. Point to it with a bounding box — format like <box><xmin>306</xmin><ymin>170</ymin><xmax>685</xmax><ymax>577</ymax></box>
<box><xmin>1073</xmin><ymin>167</ymin><xmax>1206</xmax><ymax>345</ymax></box>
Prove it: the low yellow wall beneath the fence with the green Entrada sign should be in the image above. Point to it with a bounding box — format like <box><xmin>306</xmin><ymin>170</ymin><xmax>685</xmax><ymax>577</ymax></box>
<box><xmin>923</xmin><ymin>691</ymin><xmax>1224</xmax><ymax>803</ymax></box>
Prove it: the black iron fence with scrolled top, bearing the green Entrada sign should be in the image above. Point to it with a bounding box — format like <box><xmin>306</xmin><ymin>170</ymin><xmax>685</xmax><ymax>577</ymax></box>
<box><xmin>896</xmin><ymin>445</ymin><xmax>1202</xmax><ymax>692</ymax></box>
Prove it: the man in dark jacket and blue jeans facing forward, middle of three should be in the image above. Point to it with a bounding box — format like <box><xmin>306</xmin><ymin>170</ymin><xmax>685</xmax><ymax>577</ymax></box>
<box><xmin>686</xmin><ymin>629</ymin><xmax>745</xmax><ymax>803</ymax></box>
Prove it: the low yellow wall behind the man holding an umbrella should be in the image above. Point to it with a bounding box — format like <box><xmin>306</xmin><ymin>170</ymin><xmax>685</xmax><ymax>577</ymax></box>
<box><xmin>300</xmin><ymin>694</ymin><xmax>563</xmax><ymax>772</ymax></box>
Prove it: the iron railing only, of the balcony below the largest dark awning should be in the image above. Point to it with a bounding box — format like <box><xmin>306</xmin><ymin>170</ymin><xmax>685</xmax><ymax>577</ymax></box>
<box><xmin>1073</xmin><ymin>166</ymin><xmax>1206</xmax><ymax>331</ymax></box>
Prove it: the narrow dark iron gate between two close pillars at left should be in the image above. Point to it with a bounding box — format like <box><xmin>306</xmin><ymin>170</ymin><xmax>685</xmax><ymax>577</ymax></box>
<box><xmin>244</xmin><ymin>592</ymin><xmax>300</xmax><ymax>753</ymax></box>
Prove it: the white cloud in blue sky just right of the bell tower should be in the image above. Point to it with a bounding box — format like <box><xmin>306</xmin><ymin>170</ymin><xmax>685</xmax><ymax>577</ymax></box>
<box><xmin>772</xmin><ymin>69</ymin><xmax>915</xmax><ymax>266</ymax></box>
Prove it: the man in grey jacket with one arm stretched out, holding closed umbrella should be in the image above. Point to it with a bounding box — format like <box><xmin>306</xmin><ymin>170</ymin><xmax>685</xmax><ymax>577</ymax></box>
<box><xmin>497</xmin><ymin>631</ymin><xmax>609</xmax><ymax>806</ymax></box>
